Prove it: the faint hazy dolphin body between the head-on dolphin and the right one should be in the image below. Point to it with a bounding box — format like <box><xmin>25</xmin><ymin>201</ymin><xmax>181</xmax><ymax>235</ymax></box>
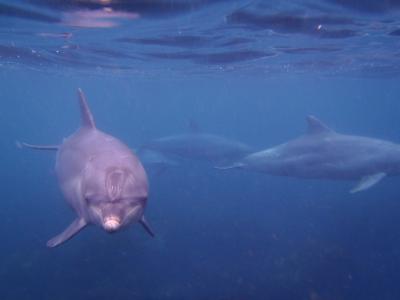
<box><xmin>140</xmin><ymin>132</ymin><xmax>254</xmax><ymax>164</ymax></box>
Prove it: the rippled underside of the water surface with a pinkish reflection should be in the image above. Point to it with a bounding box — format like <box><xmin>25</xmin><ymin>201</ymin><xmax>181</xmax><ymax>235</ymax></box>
<box><xmin>0</xmin><ymin>0</ymin><xmax>400</xmax><ymax>77</ymax></box>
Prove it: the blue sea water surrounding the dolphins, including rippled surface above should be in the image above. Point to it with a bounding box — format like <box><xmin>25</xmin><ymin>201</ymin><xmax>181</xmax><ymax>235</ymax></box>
<box><xmin>0</xmin><ymin>0</ymin><xmax>400</xmax><ymax>300</ymax></box>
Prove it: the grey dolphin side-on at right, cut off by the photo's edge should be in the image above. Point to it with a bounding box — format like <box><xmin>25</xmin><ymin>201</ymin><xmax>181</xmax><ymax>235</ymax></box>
<box><xmin>220</xmin><ymin>116</ymin><xmax>400</xmax><ymax>193</ymax></box>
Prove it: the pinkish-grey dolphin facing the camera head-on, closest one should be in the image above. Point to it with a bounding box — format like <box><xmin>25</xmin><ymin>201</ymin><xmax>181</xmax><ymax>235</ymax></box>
<box><xmin>19</xmin><ymin>89</ymin><xmax>154</xmax><ymax>247</ymax></box>
